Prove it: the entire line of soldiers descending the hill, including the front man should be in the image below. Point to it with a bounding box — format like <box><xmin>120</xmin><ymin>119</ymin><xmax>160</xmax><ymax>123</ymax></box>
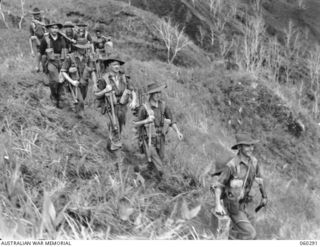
<box><xmin>30</xmin><ymin>8</ymin><xmax>267</xmax><ymax>239</ymax></box>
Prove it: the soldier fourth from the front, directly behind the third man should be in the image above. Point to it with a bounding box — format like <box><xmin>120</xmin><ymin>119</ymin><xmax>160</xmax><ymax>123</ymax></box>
<box><xmin>61</xmin><ymin>39</ymin><xmax>96</xmax><ymax>115</ymax></box>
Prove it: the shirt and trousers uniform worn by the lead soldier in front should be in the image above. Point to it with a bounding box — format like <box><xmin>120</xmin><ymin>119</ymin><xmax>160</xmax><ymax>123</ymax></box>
<box><xmin>214</xmin><ymin>134</ymin><xmax>267</xmax><ymax>240</ymax></box>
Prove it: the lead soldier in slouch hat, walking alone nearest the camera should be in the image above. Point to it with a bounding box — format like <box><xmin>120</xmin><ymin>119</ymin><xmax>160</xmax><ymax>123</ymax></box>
<box><xmin>212</xmin><ymin>133</ymin><xmax>267</xmax><ymax>240</ymax></box>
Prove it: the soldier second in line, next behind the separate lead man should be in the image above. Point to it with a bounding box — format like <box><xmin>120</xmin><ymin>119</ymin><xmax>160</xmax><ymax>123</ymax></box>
<box><xmin>134</xmin><ymin>83</ymin><xmax>183</xmax><ymax>181</ymax></box>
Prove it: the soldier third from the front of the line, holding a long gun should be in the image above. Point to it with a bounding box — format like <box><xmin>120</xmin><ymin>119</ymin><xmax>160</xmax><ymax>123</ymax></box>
<box><xmin>94</xmin><ymin>54</ymin><xmax>137</xmax><ymax>151</ymax></box>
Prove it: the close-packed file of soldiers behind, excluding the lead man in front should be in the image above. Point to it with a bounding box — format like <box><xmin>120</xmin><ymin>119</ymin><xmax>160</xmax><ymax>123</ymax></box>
<box><xmin>30</xmin><ymin>8</ymin><xmax>183</xmax><ymax>177</ymax></box>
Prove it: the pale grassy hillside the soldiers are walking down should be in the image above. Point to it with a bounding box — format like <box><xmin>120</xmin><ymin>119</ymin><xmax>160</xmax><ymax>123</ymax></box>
<box><xmin>0</xmin><ymin>0</ymin><xmax>320</xmax><ymax>239</ymax></box>
